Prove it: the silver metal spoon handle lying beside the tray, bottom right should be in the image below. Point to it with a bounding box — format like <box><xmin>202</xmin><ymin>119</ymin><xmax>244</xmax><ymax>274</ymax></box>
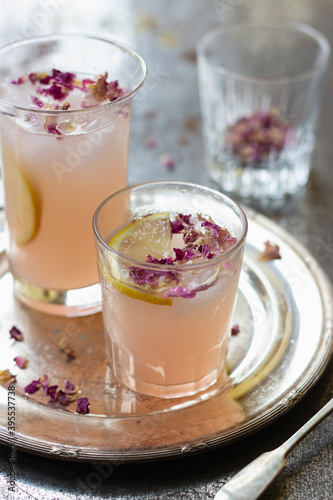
<box><xmin>214</xmin><ymin>399</ymin><xmax>333</xmax><ymax>500</ymax></box>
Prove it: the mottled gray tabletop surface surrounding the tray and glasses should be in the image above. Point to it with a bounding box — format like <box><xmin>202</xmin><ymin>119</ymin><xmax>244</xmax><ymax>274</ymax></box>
<box><xmin>0</xmin><ymin>0</ymin><xmax>333</xmax><ymax>500</ymax></box>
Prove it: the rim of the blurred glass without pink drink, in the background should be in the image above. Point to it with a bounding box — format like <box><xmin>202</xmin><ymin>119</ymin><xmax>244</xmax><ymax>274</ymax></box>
<box><xmin>196</xmin><ymin>20</ymin><xmax>331</xmax><ymax>85</ymax></box>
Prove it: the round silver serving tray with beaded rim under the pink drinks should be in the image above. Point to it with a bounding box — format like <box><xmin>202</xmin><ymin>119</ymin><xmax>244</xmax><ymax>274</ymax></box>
<box><xmin>0</xmin><ymin>210</ymin><xmax>333</xmax><ymax>462</ymax></box>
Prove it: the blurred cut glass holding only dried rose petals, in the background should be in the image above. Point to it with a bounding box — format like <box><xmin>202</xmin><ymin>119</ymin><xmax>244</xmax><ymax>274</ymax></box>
<box><xmin>198</xmin><ymin>22</ymin><xmax>330</xmax><ymax>200</ymax></box>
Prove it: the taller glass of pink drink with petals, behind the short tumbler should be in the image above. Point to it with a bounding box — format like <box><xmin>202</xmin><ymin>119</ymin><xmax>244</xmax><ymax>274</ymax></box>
<box><xmin>0</xmin><ymin>35</ymin><xmax>146</xmax><ymax>316</ymax></box>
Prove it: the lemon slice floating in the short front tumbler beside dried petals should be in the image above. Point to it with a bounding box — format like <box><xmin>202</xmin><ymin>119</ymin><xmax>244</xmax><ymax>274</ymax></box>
<box><xmin>102</xmin><ymin>212</ymin><xmax>172</xmax><ymax>306</ymax></box>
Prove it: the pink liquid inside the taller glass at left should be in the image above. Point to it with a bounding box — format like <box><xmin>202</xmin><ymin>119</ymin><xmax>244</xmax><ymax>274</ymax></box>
<box><xmin>1</xmin><ymin>104</ymin><xmax>130</xmax><ymax>291</ymax></box>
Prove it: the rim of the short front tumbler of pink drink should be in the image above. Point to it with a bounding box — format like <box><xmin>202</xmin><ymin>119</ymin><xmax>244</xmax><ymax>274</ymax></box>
<box><xmin>92</xmin><ymin>181</ymin><xmax>248</xmax><ymax>271</ymax></box>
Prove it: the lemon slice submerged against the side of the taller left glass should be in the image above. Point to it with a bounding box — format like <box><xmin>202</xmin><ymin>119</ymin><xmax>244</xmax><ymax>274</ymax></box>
<box><xmin>2</xmin><ymin>144</ymin><xmax>38</xmax><ymax>245</ymax></box>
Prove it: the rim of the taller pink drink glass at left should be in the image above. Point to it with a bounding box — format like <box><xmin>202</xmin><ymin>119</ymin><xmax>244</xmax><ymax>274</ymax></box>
<box><xmin>0</xmin><ymin>33</ymin><xmax>148</xmax><ymax>116</ymax></box>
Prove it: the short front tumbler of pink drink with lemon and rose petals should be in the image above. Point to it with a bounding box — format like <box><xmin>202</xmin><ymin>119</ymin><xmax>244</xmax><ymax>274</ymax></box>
<box><xmin>93</xmin><ymin>182</ymin><xmax>247</xmax><ymax>398</ymax></box>
